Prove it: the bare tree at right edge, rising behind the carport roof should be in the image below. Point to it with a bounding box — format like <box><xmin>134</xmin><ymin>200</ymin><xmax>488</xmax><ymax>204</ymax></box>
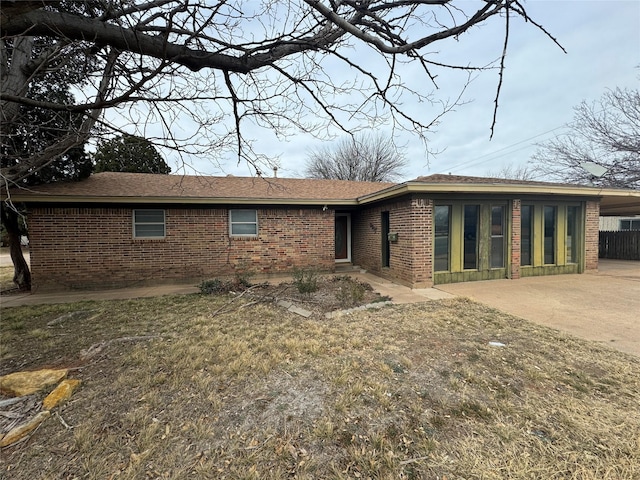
<box><xmin>533</xmin><ymin>88</ymin><xmax>640</xmax><ymax>189</ymax></box>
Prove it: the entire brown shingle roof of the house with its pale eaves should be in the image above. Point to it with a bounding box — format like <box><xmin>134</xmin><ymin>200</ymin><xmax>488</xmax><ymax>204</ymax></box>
<box><xmin>10</xmin><ymin>172</ymin><xmax>640</xmax><ymax>215</ymax></box>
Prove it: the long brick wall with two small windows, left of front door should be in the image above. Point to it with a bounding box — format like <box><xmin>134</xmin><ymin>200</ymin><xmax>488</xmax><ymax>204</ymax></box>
<box><xmin>28</xmin><ymin>207</ymin><xmax>335</xmax><ymax>289</ymax></box>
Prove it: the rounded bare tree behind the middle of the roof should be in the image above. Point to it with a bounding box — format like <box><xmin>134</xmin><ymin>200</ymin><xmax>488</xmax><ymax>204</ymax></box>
<box><xmin>305</xmin><ymin>133</ymin><xmax>407</xmax><ymax>182</ymax></box>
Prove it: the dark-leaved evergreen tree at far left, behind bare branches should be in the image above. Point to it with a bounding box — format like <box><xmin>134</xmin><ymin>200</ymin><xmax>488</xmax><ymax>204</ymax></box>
<box><xmin>0</xmin><ymin>37</ymin><xmax>93</xmax><ymax>290</ymax></box>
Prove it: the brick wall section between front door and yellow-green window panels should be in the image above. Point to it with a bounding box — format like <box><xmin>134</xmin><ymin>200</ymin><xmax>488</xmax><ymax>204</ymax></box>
<box><xmin>352</xmin><ymin>198</ymin><xmax>433</xmax><ymax>288</ymax></box>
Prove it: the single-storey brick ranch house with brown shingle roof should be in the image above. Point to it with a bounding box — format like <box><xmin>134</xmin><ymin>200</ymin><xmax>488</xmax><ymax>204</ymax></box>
<box><xmin>5</xmin><ymin>173</ymin><xmax>640</xmax><ymax>289</ymax></box>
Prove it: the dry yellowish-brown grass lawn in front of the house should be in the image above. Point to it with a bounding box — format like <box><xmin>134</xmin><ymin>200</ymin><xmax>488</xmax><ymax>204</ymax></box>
<box><xmin>0</xmin><ymin>295</ymin><xmax>640</xmax><ymax>480</ymax></box>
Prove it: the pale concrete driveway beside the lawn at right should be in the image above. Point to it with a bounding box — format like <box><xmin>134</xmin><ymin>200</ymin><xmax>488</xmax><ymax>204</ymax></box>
<box><xmin>437</xmin><ymin>259</ymin><xmax>640</xmax><ymax>356</ymax></box>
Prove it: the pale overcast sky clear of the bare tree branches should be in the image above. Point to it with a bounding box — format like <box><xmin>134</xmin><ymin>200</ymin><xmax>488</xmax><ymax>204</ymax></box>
<box><xmin>167</xmin><ymin>0</ymin><xmax>640</xmax><ymax>180</ymax></box>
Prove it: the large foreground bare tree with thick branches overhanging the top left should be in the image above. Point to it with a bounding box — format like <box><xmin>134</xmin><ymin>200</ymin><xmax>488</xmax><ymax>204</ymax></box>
<box><xmin>0</xmin><ymin>0</ymin><xmax>555</xmax><ymax>186</ymax></box>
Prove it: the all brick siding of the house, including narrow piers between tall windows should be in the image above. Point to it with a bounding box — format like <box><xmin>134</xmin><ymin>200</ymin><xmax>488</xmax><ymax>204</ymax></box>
<box><xmin>29</xmin><ymin>195</ymin><xmax>599</xmax><ymax>290</ymax></box>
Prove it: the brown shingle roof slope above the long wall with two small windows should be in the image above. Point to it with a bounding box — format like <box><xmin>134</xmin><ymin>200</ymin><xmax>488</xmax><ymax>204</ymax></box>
<box><xmin>14</xmin><ymin>172</ymin><xmax>395</xmax><ymax>201</ymax></box>
